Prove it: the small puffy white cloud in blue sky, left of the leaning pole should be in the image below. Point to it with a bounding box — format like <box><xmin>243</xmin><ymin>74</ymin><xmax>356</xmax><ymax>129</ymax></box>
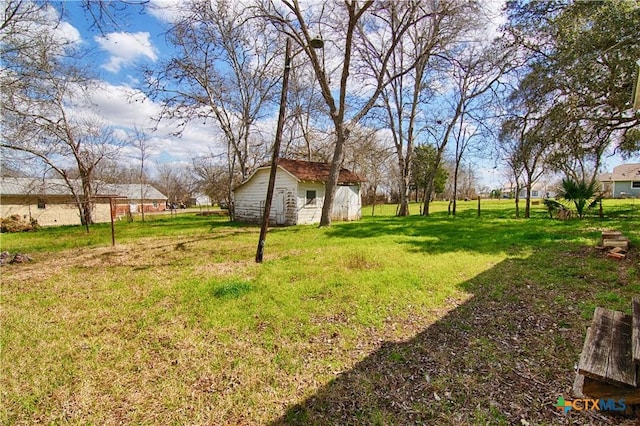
<box><xmin>95</xmin><ymin>32</ymin><xmax>158</xmax><ymax>73</ymax></box>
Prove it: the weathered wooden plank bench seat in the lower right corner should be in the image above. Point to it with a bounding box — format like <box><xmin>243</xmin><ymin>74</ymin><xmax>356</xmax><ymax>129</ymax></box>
<box><xmin>578</xmin><ymin>307</ymin><xmax>638</xmax><ymax>387</ymax></box>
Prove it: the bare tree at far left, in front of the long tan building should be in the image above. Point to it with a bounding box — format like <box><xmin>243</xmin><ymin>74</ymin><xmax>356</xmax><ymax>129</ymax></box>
<box><xmin>0</xmin><ymin>2</ymin><xmax>119</xmax><ymax>230</ymax></box>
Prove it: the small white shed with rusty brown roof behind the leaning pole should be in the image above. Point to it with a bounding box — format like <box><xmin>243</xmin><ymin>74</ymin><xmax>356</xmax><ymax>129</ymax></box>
<box><xmin>233</xmin><ymin>158</ymin><xmax>365</xmax><ymax>225</ymax></box>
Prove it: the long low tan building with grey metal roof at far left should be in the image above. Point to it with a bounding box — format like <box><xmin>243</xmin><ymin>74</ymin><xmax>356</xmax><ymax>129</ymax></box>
<box><xmin>0</xmin><ymin>177</ymin><xmax>167</xmax><ymax>226</ymax></box>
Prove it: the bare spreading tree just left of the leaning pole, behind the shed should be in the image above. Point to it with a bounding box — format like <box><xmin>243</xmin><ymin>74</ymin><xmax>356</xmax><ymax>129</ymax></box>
<box><xmin>148</xmin><ymin>0</ymin><xmax>277</xmax><ymax>192</ymax></box>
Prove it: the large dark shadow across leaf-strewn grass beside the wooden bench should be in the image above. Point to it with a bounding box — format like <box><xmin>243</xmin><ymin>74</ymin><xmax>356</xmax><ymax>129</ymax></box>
<box><xmin>272</xmin><ymin>244</ymin><xmax>640</xmax><ymax>425</ymax></box>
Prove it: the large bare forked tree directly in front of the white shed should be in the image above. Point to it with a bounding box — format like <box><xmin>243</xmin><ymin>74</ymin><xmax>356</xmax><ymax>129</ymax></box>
<box><xmin>260</xmin><ymin>0</ymin><xmax>440</xmax><ymax>226</ymax></box>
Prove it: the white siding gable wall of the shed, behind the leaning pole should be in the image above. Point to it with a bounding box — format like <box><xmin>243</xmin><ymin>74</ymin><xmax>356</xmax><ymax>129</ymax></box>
<box><xmin>233</xmin><ymin>169</ymin><xmax>297</xmax><ymax>225</ymax></box>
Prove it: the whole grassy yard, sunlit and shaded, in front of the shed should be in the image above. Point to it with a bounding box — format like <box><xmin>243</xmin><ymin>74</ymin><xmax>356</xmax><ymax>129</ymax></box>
<box><xmin>0</xmin><ymin>200</ymin><xmax>640</xmax><ymax>425</ymax></box>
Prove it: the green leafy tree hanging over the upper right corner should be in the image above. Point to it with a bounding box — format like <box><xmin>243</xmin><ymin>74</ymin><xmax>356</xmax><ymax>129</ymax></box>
<box><xmin>505</xmin><ymin>0</ymin><xmax>640</xmax><ymax>175</ymax></box>
